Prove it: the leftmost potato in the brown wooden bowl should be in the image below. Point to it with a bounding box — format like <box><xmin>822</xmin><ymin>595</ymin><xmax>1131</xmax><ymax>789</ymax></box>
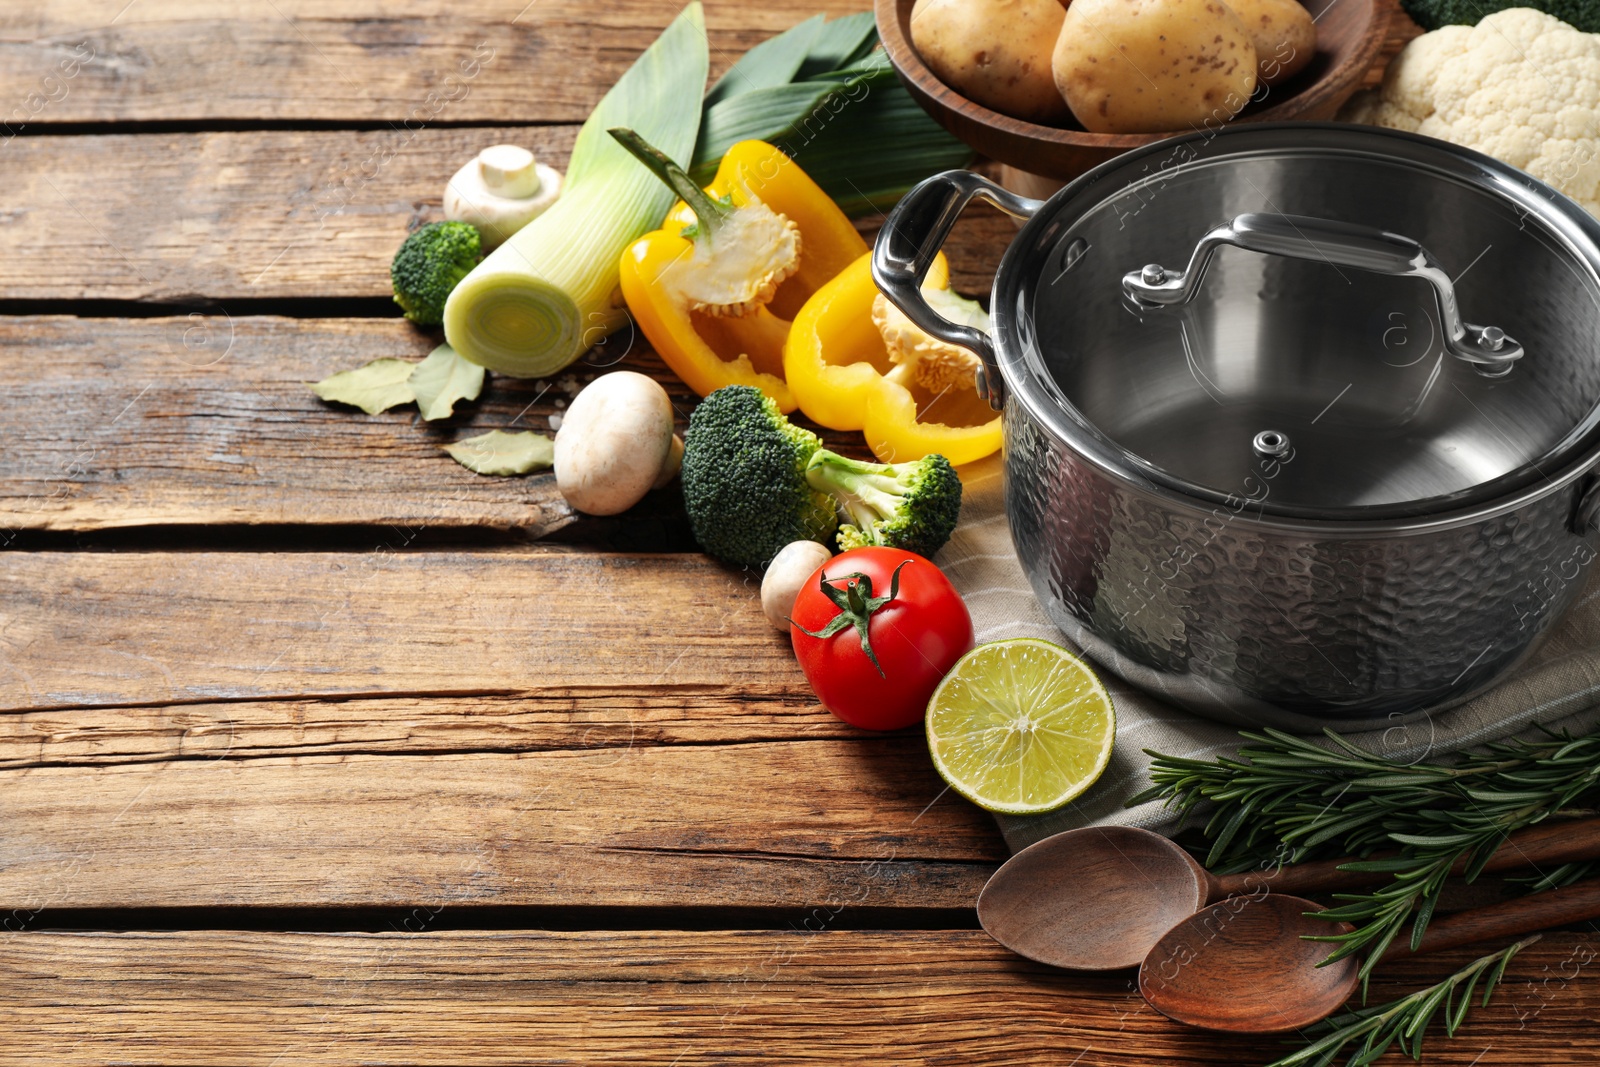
<box><xmin>910</xmin><ymin>0</ymin><xmax>1069</xmax><ymax>123</ymax></box>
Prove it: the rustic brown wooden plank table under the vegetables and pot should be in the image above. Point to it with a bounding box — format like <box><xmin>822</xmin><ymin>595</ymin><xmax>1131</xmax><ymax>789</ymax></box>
<box><xmin>0</xmin><ymin>0</ymin><xmax>1600</xmax><ymax>1067</ymax></box>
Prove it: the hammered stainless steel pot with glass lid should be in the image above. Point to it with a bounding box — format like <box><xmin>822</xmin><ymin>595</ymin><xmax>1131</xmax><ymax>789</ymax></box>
<box><xmin>872</xmin><ymin>123</ymin><xmax>1600</xmax><ymax>729</ymax></box>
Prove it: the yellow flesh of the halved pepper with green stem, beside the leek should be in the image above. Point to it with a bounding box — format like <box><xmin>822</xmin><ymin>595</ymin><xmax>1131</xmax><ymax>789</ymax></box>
<box><xmin>621</xmin><ymin>141</ymin><xmax>867</xmax><ymax>413</ymax></box>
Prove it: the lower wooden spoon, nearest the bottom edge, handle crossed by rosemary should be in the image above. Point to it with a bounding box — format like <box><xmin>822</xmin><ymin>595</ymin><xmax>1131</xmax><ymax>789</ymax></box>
<box><xmin>1139</xmin><ymin>878</ymin><xmax>1600</xmax><ymax>1033</ymax></box>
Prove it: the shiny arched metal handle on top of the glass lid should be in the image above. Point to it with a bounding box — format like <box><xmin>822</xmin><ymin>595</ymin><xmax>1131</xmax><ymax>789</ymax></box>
<box><xmin>1126</xmin><ymin>213</ymin><xmax>1523</xmax><ymax>378</ymax></box>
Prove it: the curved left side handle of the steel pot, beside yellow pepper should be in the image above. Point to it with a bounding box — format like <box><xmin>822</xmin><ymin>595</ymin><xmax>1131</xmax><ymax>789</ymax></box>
<box><xmin>872</xmin><ymin>171</ymin><xmax>1043</xmax><ymax>411</ymax></box>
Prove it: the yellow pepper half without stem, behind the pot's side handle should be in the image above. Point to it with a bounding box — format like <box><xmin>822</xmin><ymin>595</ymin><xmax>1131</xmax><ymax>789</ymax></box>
<box><xmin>784</xmin><ymin>253</ymin><xmax>1000</xmax><ymax>466</ymax></box>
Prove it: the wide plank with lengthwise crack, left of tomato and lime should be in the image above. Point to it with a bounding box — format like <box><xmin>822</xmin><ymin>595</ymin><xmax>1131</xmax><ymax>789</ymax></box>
<box><xmin>0</xmin><ymin>547</ymin><xmax>1005</xmax><ymax>909</ymax></box>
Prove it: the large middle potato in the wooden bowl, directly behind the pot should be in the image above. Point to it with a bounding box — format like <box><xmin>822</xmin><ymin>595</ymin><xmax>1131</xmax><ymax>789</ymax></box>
<box><xmin>1051</xmin><ymin>0</ymin><xmax>1256</xmax><ymax>133</ymax></box>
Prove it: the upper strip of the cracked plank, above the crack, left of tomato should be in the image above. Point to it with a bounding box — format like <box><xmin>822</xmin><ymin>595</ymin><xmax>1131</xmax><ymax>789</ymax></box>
<box><xmin>0</xmin><ymin>547</ymin><xmax>787</xmax><ymax>710</ymax></box>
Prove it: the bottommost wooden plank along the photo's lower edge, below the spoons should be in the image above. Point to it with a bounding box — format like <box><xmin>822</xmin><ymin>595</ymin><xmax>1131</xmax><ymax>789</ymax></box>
<box><xmin>0</xmin><ymin>927</ymin><xmax>1600</xmax><ymax>1067</ymax></box>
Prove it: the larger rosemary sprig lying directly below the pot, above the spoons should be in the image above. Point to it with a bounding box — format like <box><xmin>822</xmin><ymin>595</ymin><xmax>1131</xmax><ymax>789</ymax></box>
<box><xmin>1128</xmin><ymin>729</ymin><xmax>1600</xmax><ymax>982</ymax></box>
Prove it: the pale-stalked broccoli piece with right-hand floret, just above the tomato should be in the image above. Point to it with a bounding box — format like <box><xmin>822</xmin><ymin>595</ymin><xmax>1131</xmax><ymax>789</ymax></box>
<box><xmin>805</xmin><ymin>448</ymin><xmax>962</xmax><ymax>557</ymax></box>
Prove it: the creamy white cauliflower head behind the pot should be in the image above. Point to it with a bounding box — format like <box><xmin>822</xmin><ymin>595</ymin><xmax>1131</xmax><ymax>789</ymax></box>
<box><xmin>1339</xmin><ymin>8</ymin><xmax>1600</xmax><ymax>214</ymax></box>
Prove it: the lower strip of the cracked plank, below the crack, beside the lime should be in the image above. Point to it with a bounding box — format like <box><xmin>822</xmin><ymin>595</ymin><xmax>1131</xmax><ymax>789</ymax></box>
<box><xmin>0</xmin><ymin>742</ymin><xmax>1005</xmax><ymax>910</ymax></box>
